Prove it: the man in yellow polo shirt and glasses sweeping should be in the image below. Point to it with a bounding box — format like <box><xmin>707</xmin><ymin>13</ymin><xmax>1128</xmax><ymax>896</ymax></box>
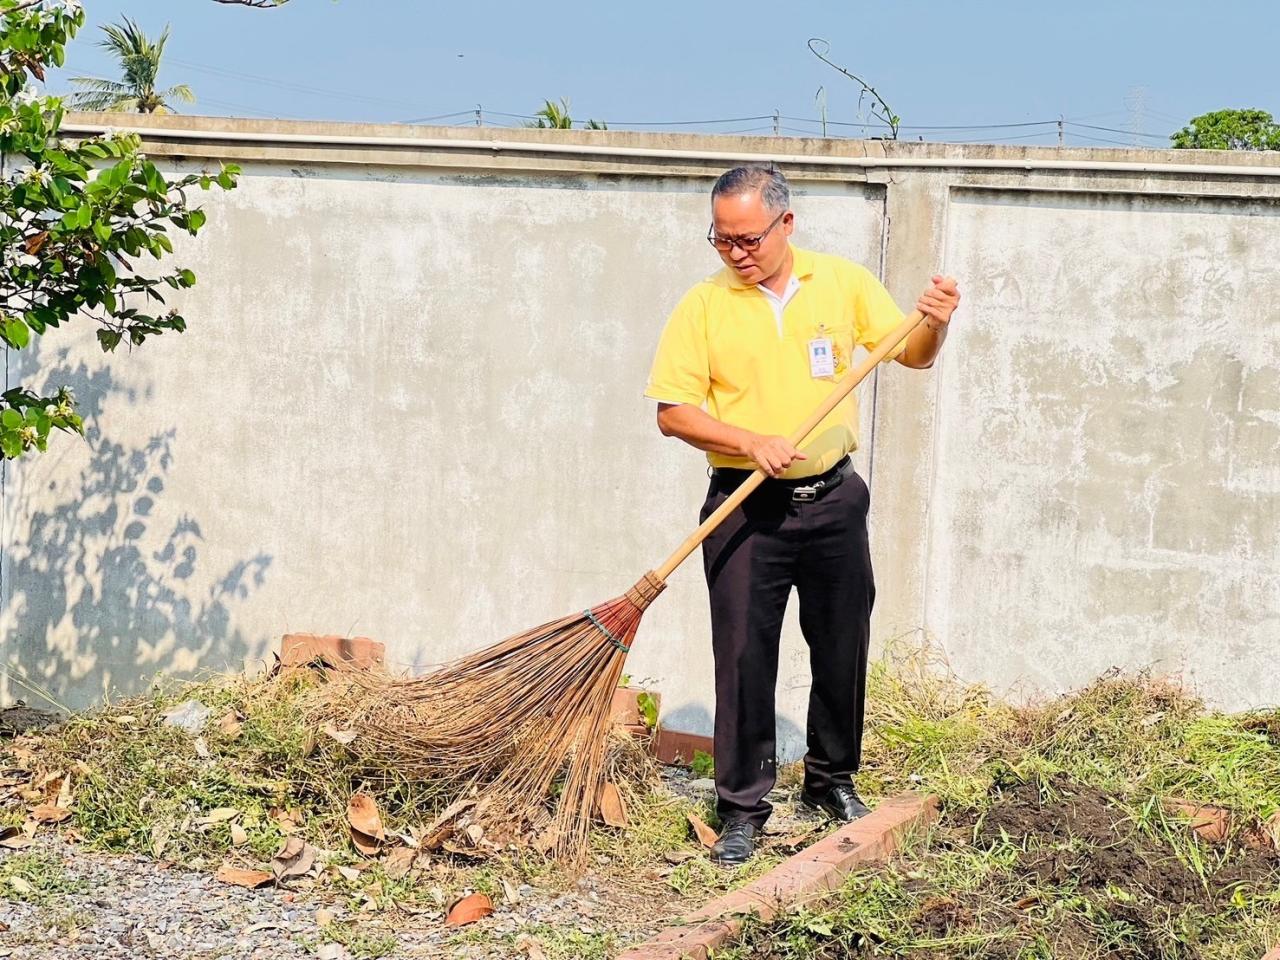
<box><xmin>645</xmin><ymin>166</ymin><xmax>960</xmax><ymax>864</ymax></box>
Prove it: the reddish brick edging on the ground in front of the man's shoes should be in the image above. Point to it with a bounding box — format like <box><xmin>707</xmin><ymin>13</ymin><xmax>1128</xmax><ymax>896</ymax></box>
<box><xmin>617</xmin><ymin>794</ymin><xmax>942</xmax><ymax>960</ymax></box>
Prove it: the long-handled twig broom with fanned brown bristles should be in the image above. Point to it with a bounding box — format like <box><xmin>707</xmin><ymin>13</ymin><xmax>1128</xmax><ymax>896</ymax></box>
<box><xmin>320</xmin><ymin>305</ymin><xmax>924</xmax><ymax>860</ymax></box>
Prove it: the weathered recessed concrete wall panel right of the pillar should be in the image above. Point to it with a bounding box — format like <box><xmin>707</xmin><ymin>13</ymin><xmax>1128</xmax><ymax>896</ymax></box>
<box><xmin>925</xmin><ymin>191</ymin><xmax>1280</xmax><ymax>705</ymax></box>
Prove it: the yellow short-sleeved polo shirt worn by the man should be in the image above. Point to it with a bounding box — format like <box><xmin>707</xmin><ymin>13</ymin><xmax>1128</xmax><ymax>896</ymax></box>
<box><xmin>644</xmin><ymin>247</ymin><xmax>906</xmax><ymax>477</ymax></box>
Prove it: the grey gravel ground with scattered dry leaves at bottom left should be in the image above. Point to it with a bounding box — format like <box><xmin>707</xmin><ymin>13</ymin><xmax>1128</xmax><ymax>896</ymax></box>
<box><xmin>0</xmin><ymin>768</ymin><xmax>820</xmax><ymax>960</ymax></box>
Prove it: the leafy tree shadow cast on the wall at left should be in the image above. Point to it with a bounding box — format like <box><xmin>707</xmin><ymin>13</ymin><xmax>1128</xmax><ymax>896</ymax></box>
<box><xmin>0</xmin><ymin>351</ymin><xmax>271</xmax><ymax>709</ymax></box>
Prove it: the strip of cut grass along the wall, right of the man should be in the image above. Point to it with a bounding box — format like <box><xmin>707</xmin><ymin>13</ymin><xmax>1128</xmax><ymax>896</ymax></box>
<box><xmin>855</xmin><ymin>649</ymin><xmax>1280</xmax><ymax>828</ymax></box>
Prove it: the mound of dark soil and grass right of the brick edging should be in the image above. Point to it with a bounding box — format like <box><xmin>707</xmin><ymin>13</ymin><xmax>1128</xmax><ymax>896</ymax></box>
<box><xmin>726</xmin><ymin>777</ymin><xmax>1280</xmax><ymax>960</ymax></box>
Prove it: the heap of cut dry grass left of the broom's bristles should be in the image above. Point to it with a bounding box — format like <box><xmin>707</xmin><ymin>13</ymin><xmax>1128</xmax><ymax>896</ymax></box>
<box><xmin>18</xmin><ymin>671</ymin><xmax>445</xmax><ymax>865</ymax></box>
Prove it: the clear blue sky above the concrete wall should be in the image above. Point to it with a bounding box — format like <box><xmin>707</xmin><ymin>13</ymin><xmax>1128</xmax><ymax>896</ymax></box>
<box><xmin>49</xmin><ymin>0</ymin><xmax>1280</xmax><ymax>146</ymax></box>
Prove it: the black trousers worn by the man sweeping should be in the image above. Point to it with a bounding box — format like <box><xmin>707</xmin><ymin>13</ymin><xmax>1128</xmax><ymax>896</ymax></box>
<box><xmin>701</xmin><ymin>466</ymin><xmax>876</xmax><ymax>827</ymax></box>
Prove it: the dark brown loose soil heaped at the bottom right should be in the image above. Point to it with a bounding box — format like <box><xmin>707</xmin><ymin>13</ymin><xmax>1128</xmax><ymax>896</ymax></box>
<box><xmin>750</xmin><ymin>781</ymin><xmax>1280</xmax><ymax>960</ymax></box>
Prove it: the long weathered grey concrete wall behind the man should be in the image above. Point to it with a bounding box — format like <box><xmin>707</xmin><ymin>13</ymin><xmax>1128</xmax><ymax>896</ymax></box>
<box><xmin>0</xmin><ymin>116</ymin><xmax>1280</xmax><ymax>755</ymax></box>
